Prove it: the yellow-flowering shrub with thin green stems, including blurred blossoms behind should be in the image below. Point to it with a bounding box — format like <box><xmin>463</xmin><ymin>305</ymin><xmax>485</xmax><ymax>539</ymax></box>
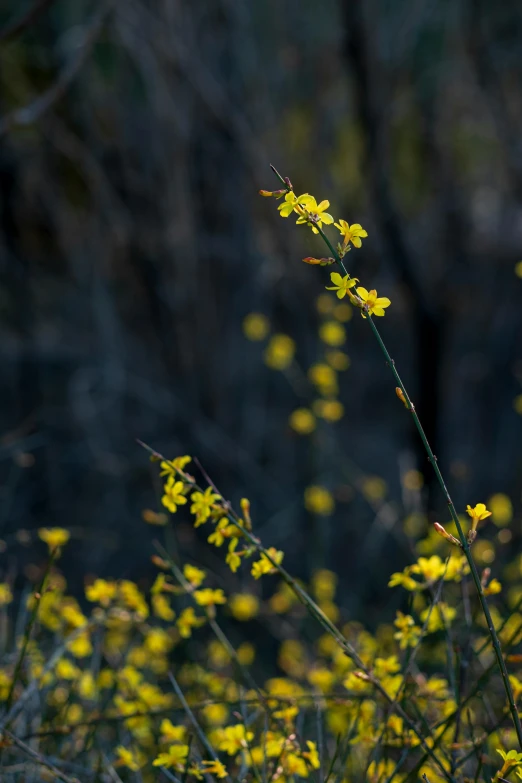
<box><xmin>0</xmin><ymin>167</ymin><xmax>522</xmax><ymax>783</ymax></box>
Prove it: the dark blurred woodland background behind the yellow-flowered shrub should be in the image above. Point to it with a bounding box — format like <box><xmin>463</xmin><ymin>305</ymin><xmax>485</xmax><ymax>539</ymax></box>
<box><xmin>0</xmin><ymin>0</ymin><xmax>522</xmax><ymax>617</ymax></box>
